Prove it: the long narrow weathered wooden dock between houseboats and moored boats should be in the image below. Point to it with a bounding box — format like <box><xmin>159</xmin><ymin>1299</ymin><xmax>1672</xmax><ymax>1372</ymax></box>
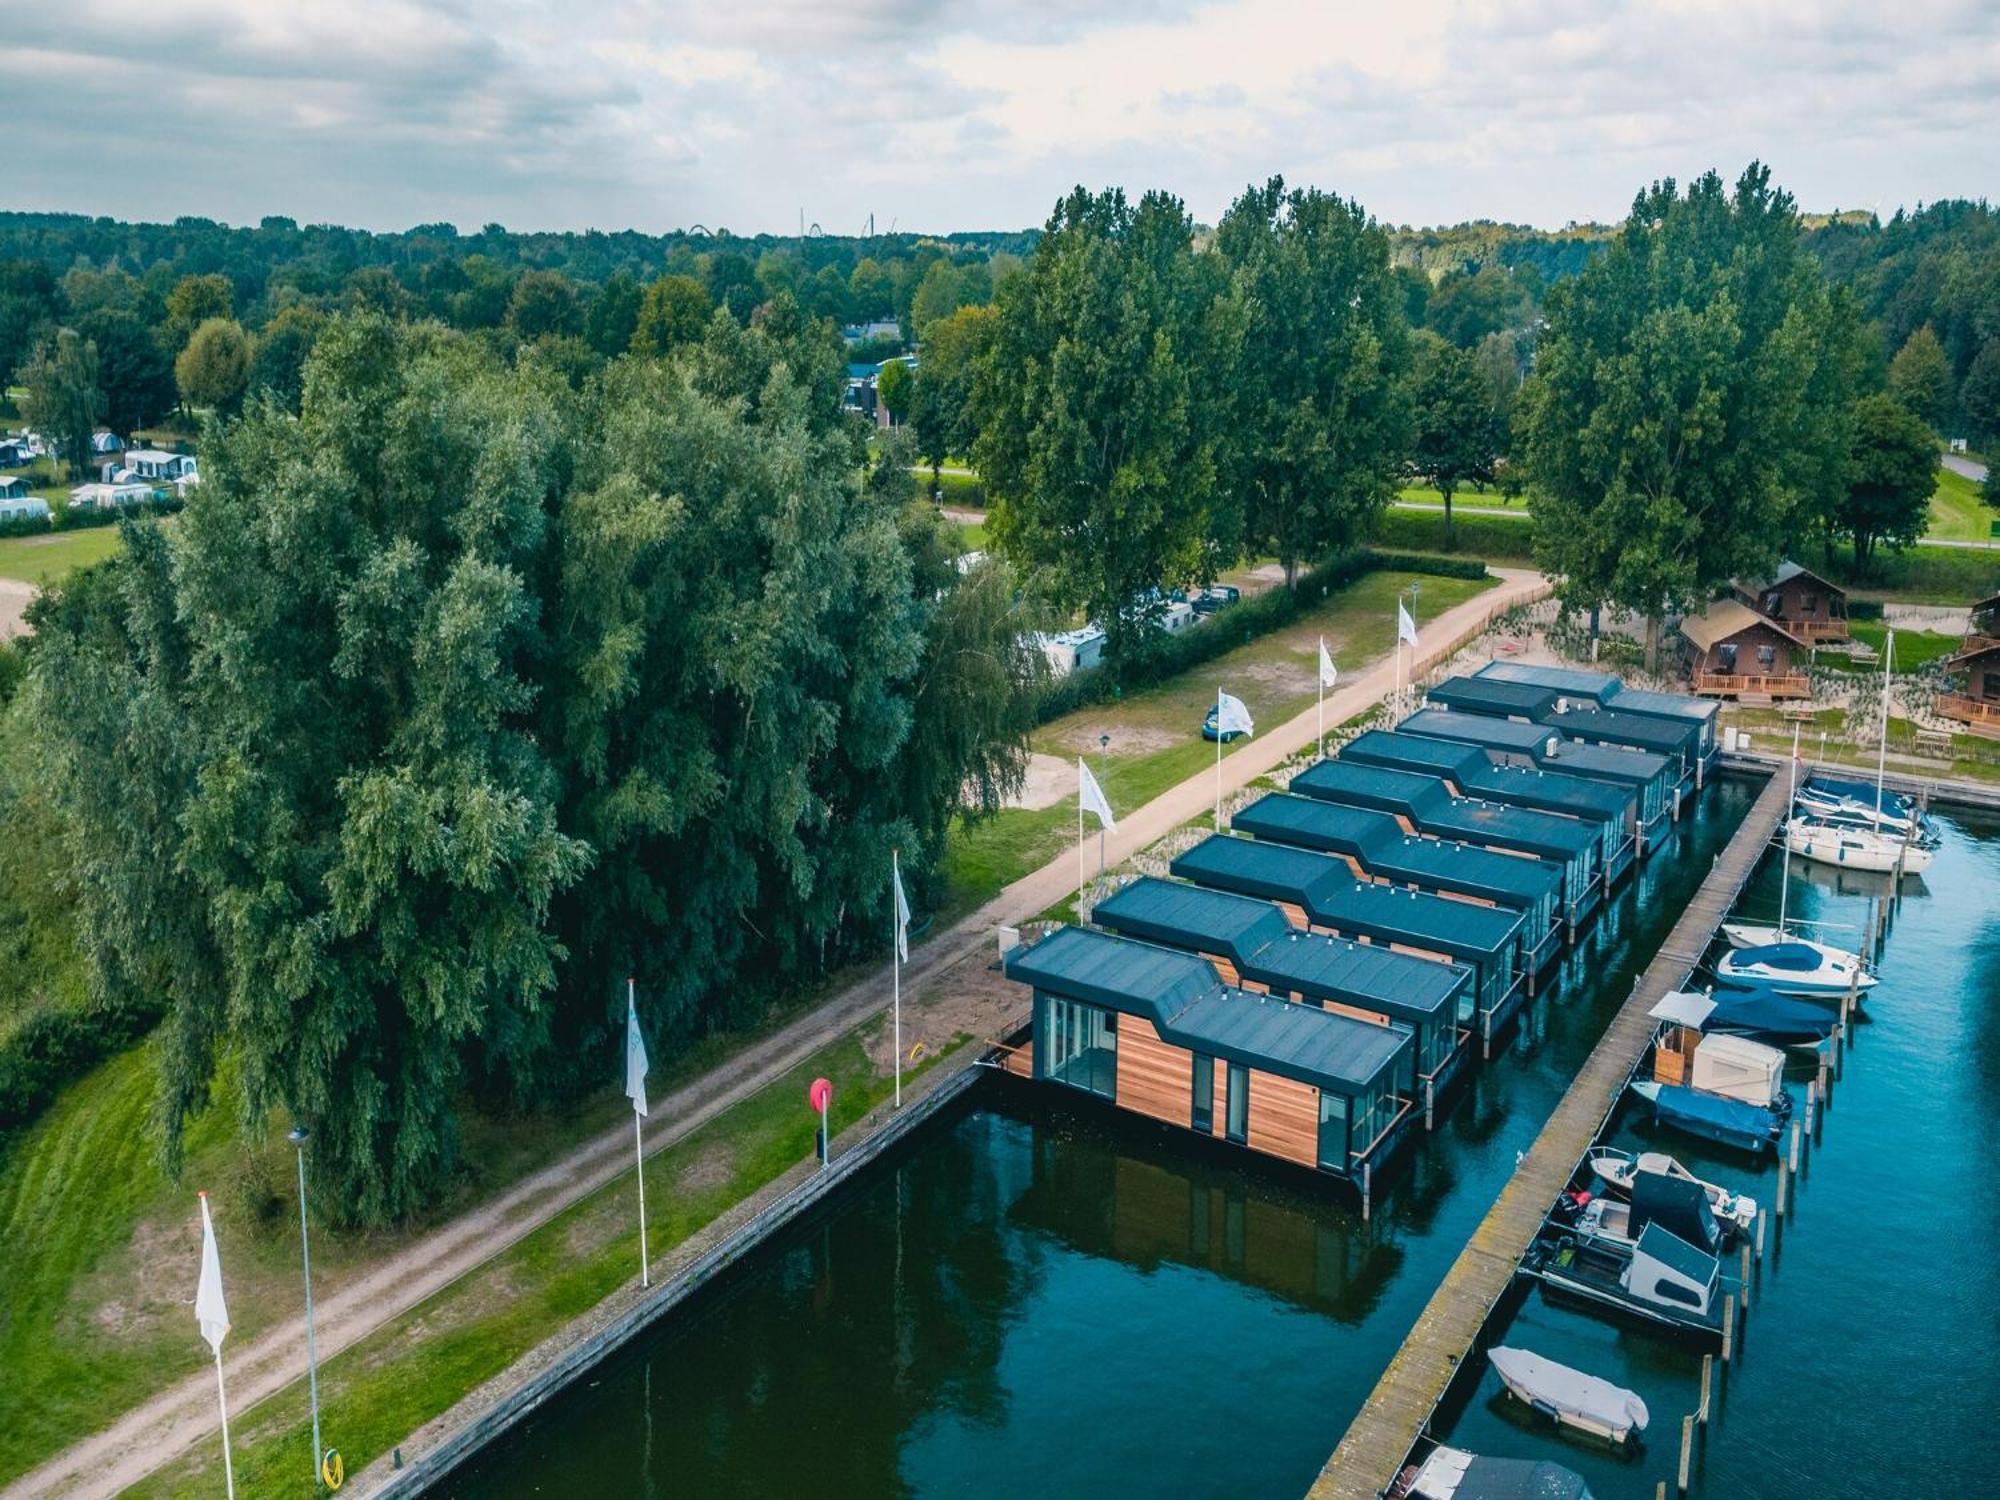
<box><xmin>1308</xmin><ymin>776</ymin><xmax>1786</xmax><ymax>1500</ymax></box>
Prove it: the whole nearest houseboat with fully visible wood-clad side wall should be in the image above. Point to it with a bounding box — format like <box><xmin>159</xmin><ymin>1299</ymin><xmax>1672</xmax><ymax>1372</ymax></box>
<box><xmin>1006</xmin><ymin>926</ymin><xmax>1414</xmax><ymax>1194</ymax></box>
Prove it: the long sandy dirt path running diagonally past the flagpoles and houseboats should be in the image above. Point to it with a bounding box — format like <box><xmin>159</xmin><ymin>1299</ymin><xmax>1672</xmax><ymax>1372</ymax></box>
<box><xmin>0</xmin><ymin>568</ymin><xmax>1548</xmax><ymax>1500</ymax></box>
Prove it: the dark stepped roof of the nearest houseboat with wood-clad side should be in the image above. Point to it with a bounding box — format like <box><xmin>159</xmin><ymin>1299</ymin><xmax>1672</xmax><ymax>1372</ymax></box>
<box><xmin>1006</xmin><ymin>926</ymin><xmax>1410</xmax><ymax>1094</ymax></box>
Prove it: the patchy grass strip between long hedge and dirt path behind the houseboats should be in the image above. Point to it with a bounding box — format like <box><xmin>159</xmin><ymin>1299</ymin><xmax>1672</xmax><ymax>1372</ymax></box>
<box><xmin>938</xmin><ymin>568</ymin><xmax>1506</xmax><ymax>926</ymax></box>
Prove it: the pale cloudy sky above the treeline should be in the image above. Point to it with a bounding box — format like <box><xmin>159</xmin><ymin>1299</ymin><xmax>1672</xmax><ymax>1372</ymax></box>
<box><xmin>0</xmin><ymin>0</ymin><xmax>2000</xmax><ymax>234</ymax></box>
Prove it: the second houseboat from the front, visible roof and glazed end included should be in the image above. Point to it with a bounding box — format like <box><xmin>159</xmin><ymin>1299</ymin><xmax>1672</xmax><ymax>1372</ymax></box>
<box><xmin>1090</xmin><ymin>876</ymin><xmax>1472</xmax><ymax>1124</ymax></box>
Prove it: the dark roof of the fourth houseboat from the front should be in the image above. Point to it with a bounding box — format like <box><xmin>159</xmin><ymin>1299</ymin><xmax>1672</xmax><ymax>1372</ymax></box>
<box><xmin>1234</xmin><ymin>792</ymin><xmax>1562</xmax><ymax>906</ymax></box>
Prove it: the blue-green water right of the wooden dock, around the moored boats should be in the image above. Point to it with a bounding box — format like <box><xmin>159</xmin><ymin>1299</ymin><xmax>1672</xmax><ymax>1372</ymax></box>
<box><xmin>1452</xmin><ymin>816</ymin><xmax>2000</xmax><ymax>1500</ymax></box>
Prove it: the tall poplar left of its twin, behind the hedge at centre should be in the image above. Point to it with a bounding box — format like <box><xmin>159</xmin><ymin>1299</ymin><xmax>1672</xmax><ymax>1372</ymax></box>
<box><xmin>974</xmin><ymin>188</ymin><xmax>1242</xmax><ymax>660</ymax></box>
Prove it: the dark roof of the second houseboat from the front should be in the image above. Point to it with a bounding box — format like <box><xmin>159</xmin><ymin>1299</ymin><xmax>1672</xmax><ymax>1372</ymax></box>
<box><xmin>1092</xmin><ymin>876</ymin><xmax>1472</xmax><ymax>1022</ymax></box>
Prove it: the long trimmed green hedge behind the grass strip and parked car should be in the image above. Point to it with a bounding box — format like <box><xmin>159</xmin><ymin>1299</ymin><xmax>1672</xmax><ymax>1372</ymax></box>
<box><xmin>1036</xmin><ymin>546</ymin><xmax>1486</xmax><ymax>724</ymax></box>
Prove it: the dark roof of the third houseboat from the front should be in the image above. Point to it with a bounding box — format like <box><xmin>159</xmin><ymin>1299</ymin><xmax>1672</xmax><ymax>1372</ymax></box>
<box><xmin>1172</xmin><ymin>834</ymin><xmax>1526</xmax><ymax>962</ymax></box>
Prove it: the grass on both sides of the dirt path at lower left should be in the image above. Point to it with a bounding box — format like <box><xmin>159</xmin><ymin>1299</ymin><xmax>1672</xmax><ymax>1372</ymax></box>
<box><xmin>0</xmin><ymin>1012</ymin><xmax>930</xmax><ymax>1494</ymax></box>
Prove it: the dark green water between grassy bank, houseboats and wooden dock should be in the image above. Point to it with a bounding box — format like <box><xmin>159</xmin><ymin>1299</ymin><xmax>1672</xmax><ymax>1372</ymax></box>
<box><xmin>444</xmin><ymin>782</ymin><xmax>1768</xmax><ymax>1500</ymax></box>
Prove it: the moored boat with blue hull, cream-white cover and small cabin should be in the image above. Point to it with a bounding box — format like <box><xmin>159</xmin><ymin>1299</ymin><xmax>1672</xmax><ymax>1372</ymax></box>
<box><xmin>1632</xmin><ymin>994</ymin><xmax>1792</xmax><ymax>1152</ymax></box>
